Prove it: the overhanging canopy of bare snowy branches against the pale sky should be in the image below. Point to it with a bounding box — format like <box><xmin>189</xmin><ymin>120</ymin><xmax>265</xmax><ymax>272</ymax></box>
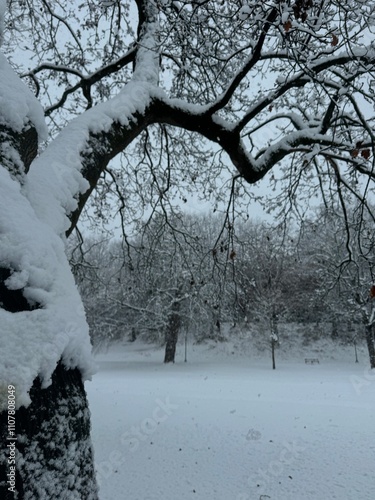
<box><xmin>4</xmin><ymin>0</ymin><xmax>375</xmax><ymax>238</ymax></box>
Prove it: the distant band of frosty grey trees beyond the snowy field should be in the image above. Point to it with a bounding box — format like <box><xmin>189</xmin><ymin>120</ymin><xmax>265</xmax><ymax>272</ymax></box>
<box><xmin>69</xmin><ymin>209</ymin><xmax>375</xmax><ymax>365</ymax></box>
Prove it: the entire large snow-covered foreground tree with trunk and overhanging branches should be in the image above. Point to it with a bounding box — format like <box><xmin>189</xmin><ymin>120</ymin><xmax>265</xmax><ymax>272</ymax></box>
<box><xmin>0</xmin><ymin>0</ymin><xmax>375</xmax><ymax>499</ymax></box>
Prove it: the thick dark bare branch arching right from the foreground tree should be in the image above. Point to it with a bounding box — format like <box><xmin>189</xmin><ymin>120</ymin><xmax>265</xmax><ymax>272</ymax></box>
<box><xmin>68</xmin><ymin>84</ymin><xmax>370</xmax><ymax>238</ymax></box>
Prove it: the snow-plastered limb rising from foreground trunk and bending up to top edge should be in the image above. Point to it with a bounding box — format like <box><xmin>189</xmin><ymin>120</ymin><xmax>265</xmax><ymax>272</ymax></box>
<box><xmin>25</xmin><ymin>2</ymin><xmax>162</xmax><ymax>234</ymax></box>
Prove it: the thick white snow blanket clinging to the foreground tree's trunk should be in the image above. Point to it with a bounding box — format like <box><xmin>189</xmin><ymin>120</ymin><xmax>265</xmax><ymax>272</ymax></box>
<box><xmin>0</xmin><ymin>168</ymin><xmax>92</xmax><ymax>410</ymax></box>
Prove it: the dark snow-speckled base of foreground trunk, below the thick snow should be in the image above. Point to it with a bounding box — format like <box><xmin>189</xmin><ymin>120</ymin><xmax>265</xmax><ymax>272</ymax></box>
<box><xmin>0</xmin><ymin>363</ymin><xmax>98</xmax><ymax>500</ymax></box>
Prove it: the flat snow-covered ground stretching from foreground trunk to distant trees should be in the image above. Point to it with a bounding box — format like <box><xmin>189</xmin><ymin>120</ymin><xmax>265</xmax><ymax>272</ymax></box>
<box><xmin>86</xmin><ymin>343</ymin><xmax>375</xmax><ymax>500</ymax></box>
